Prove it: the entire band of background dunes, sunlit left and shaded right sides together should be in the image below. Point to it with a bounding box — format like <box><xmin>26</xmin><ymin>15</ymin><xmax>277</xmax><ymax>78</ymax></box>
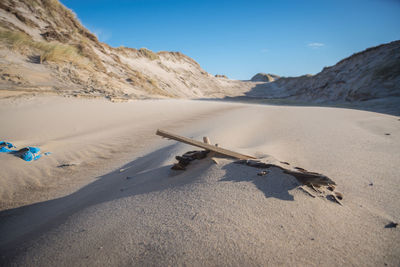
<box><xmin>0</xmin><ymin>0</ymin><xmax>400</xmax><ymax>108</ymax></box>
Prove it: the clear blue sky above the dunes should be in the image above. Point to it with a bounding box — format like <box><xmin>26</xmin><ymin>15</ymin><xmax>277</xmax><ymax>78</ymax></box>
<box><xmin>61</xmin><ymin>0</ymin><xmax>400</xmax><ymax>79</ymax></box>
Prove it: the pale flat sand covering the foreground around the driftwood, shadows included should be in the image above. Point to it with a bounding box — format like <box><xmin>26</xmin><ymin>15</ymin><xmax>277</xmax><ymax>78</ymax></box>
<box><xmin>0</xmin><ymin>97</ymin><xmax>400</xmax><ymax>266</ymax></box>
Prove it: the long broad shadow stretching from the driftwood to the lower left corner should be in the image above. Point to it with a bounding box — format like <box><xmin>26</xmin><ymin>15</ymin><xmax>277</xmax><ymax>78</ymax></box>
<box><xmin>0</xmin><ymin>146</ymin><xmax>206</xmax><ymax>266</ymax></box>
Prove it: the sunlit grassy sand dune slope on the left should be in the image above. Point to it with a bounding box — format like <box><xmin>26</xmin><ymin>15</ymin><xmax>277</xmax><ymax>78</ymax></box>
<box><xmin>0</xmin><ymin>0</ymin><xmax>251</xmax><ymax>101</ymax></box>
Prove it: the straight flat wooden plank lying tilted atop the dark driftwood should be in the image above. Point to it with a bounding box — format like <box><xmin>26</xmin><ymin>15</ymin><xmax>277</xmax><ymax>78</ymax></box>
<box><xmin>156</xmin><ymin>129</ymin><xmax>256</xmax><ymax>159</ymax></box>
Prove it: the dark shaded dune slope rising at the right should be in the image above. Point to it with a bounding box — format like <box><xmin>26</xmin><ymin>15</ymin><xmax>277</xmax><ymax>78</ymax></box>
<box><xmin>247</xmin><ymin>41</ymin><xmax>400</xmax><ymax>102</ymax></box>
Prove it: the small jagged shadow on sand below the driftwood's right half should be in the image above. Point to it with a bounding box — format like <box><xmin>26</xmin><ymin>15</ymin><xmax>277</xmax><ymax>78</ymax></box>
<box><xmin>220</xmin><ymin>163</ymin><xmax>300</xmax><ymax>201</ymax></box>
